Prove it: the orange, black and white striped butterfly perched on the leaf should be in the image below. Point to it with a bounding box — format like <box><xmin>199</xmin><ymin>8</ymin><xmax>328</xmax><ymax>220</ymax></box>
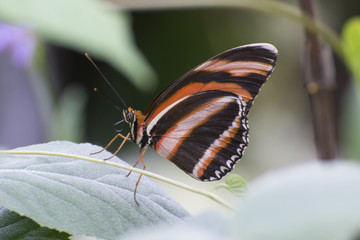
<box><xmin>90</xmin><ymin>43</ymin><xmax>277</xmax><ymax>202</ymax></box>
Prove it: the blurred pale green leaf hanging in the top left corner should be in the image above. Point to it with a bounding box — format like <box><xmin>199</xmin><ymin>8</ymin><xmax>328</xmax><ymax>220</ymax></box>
<box><xmin>0</xmin><ymin>0</ymin><xmax>155</xmax><ymax>90</ymax></box>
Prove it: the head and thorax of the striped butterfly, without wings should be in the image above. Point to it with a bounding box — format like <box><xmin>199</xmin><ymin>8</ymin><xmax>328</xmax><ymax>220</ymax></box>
<box><xmin>123</xmin><ymin>107</ymin><xmax>151</xmax><ymax>151</ymax></box>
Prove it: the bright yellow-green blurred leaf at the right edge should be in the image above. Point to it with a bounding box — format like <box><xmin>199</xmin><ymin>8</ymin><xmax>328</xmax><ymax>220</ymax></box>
<box><xmin>342</xmin><ymin>16</ymin><xmax>360</xmax><ymax>89</ymax></box>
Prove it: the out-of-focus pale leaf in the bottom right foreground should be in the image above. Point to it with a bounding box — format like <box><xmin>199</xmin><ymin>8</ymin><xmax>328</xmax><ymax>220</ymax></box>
<box><xmin>232</xmin><ymin>160</ymin><xmax>360</xmax><ymax>240</ymax></box>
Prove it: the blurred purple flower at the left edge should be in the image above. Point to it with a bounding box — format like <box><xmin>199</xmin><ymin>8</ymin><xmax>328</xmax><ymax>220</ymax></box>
<box><xmin>0</xmin><ymin>23</ymin><xmax>36</xmax><ymax>68</ymax></box>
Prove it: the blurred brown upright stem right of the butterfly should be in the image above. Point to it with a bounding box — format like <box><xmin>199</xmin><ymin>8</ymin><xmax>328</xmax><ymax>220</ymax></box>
<box><xmin>300</xmin><ymin>0</ymin><xmax>339</xmax><ymax>160</ymax></box>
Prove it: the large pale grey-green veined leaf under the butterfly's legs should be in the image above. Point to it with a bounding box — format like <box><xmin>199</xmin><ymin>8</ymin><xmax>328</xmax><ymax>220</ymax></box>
<box><xmin>0</xmin><ymin>142</ymin><xmax>188</xmax><ymax>239</ymax></box>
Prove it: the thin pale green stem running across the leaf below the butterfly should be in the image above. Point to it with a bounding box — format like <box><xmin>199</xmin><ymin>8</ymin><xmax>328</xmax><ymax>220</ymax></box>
<box><xmin>0</xmin><ymin>150</ymin><xmax>232</xmax><ymax>209</ymax></box>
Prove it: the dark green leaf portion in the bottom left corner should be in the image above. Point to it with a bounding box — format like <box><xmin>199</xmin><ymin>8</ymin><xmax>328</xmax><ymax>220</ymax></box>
<box><xmin>0</xmin><ymin>206</ymin><xmax>70</xmax><ymax>240</ymax></box>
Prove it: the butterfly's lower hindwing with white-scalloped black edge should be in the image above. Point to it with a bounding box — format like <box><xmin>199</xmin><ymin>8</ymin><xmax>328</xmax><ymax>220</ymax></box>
<box><xmin>151</xmin><ymin>90</ymin><xmax>248</xmax><ymax>181</ymax></box>
